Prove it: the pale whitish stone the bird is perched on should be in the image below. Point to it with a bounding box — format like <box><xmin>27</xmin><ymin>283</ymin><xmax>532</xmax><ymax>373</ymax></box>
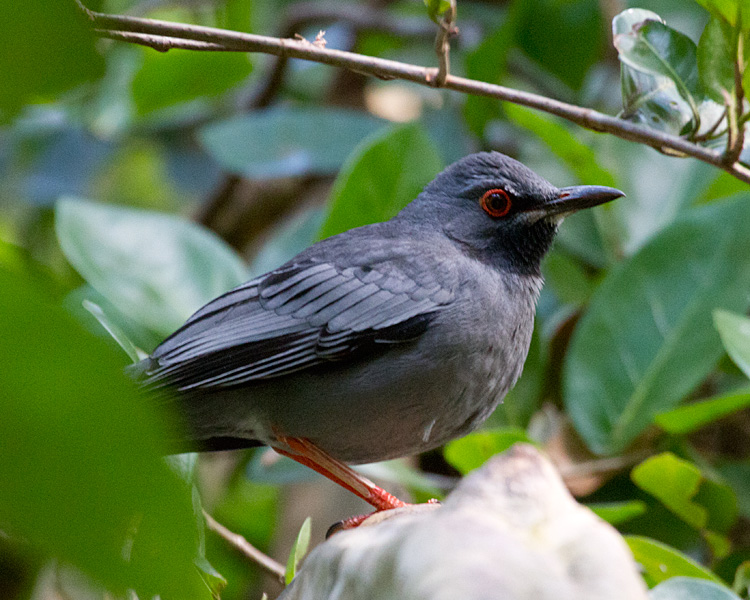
<box><xmin>280</xmin><ymin>445</ymin><xmax>647</xmax><ymax>600</ymax></box>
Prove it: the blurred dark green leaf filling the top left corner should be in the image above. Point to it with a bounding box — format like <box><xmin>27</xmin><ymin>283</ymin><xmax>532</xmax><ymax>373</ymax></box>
<box><xmin>0</xmin><ymin>0</ymin><xmax>104</xmax><ymax>120</ymax></box>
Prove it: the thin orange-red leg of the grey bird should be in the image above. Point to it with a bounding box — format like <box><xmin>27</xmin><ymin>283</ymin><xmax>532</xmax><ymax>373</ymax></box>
<box><xmin>274</xmin><ymin>435</ymin><xmax>406</xmax><ymax>510</ymax></box>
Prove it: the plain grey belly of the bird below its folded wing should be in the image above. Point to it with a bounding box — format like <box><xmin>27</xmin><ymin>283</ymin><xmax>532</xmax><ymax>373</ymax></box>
<box><xmin>256</xmin><ymin>336</ymin><xmax>517</xmax><ymax>464</ymax></box>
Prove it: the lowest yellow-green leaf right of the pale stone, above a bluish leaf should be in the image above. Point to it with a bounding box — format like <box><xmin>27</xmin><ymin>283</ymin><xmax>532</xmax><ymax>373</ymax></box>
<box><xmin>625</xmin><ymin>535</ymin><xmax>721</xmax><ymax>585</ymax></box>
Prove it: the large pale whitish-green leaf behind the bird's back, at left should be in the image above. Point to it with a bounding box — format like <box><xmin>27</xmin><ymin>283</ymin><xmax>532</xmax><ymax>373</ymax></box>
<box><xmin>55</xmin><ymin>198</ymin><xmax>248</xmax><ymax>335</ymax></box>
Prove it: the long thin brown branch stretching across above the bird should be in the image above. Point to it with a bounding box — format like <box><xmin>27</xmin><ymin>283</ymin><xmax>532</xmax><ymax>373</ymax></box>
<box><xmin>82</xmin><ymin>11</ymin><xmax>750</xmax><ymax>183</ymax></box>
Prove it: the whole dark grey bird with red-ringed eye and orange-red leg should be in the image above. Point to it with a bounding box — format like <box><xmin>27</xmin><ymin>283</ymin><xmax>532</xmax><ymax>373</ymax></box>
<box><xmin>131</xmin><ymin>151</ymin><xmax>624</xmax><ymax>511</ymax></box>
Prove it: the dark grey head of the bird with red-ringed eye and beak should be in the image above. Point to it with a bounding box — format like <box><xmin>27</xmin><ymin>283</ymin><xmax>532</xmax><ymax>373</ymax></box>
<box><xmin>403</xmin><ymin>152</ymin><xmax>625</xmax><ymax>273</ymax></box>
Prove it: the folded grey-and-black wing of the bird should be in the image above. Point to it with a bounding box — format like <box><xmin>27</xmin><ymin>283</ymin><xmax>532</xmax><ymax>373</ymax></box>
<box><xmin>145</xmin><ymin>260</ymin><xmax>455</xmax><ymax>390</ymax></box>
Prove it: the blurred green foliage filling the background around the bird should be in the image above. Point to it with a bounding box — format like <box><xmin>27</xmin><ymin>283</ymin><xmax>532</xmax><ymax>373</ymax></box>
<box><xmin>0</xmin><ymin>0</ymin><xmax>750</xmax><ymax>600</ymax></box>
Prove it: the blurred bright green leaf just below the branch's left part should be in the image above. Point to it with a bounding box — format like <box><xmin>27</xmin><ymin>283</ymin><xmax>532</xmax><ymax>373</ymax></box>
<box><xmin>133</xmin><ymin>48</ymin><xmax>252</xmax><ymax>115</ymax></box>
